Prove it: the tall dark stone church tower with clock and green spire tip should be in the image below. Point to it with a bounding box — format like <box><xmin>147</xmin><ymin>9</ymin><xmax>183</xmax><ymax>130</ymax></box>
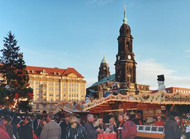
<box><xmin>115</xmin><ymin>7</ymin><xmax>136</xmax><ymax>88</ymax></box>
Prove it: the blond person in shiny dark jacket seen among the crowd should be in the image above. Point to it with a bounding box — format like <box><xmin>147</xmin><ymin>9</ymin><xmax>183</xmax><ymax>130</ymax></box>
<box><xmin>66</xmin><ymin>116</ymin><xmax>86</xmax><ymax>139</ymax></box>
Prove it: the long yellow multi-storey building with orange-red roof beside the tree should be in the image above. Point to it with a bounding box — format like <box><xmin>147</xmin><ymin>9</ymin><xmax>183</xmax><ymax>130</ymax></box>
<box><xmin>26</xmin><ymin>66</ymin><xmax>86</xmax><ymax>112</ymax></box>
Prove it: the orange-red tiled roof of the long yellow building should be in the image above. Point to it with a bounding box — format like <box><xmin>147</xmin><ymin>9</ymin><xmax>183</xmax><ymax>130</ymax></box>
<box><xmin>26</xmin><ymin>66</ymin><xmax>84</xmax><ymax>78</ymax></box>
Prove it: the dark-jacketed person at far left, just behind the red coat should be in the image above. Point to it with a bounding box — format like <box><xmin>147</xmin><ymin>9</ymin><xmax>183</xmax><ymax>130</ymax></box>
<box><xmin>2</xmin><ymin>117</ymin><xmax>13</xmax><ymax>139</ymax></box>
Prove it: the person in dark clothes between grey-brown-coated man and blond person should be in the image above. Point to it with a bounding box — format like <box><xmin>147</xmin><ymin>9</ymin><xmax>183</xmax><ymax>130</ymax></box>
<box><xmin>59</xmin><ymin>114</ymin><xmax>70</xmax><ymax>139</ymax></box>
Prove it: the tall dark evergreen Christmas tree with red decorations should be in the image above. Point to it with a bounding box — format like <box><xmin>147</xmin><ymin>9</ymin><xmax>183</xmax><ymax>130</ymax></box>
<box><xmin>0</xmin><ymin>32</ymin><xmax>33</xmax><ymax>112</ymax></box>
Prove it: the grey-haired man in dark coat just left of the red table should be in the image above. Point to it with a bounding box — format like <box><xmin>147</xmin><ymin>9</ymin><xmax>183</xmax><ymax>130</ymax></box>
<box><xmin>84</xmin><ymin>114</ymin><xmax>101</xmax><ymax>139</ymax></box>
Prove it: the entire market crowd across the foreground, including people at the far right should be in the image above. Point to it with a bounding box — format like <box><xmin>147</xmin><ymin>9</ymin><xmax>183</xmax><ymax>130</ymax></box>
<box><xmin>0</xmin><ymin>113</ymin><xmax>188</xmax><ymax>139</ymax></box>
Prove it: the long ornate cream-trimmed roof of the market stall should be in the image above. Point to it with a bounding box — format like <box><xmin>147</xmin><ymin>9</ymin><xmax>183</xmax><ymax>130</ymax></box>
<box><xmin>84</xmin><ymin>91</ymin><xmax>190</xmax><ymax>112</ymax></box>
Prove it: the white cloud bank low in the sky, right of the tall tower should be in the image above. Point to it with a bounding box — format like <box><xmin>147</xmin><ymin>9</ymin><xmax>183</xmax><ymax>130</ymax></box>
<box><xmin>137</xmin><ymin>59</ymin><xmax>190</xmax><ymax>89</ymax></box>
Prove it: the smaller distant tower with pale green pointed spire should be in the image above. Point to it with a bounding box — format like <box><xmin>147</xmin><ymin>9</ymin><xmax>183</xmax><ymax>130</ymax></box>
<box><xmin>98</xmin><ymin>56</ymin><xmax>110</xmax><ymax>81</ymax></box>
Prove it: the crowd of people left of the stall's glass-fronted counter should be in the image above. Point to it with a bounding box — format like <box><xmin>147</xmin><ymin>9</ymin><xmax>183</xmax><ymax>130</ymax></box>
<box><xmin>0</xmin><ymin>113</ymin><xmax>137</xmax><ymax>139</ymax></box>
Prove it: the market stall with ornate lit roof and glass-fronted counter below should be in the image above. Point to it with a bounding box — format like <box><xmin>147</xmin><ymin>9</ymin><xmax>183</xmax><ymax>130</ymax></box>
<box><xmin>83</xmin><ymin>91</ymin><xmax>190</xmax><ymax>139</ymax></box>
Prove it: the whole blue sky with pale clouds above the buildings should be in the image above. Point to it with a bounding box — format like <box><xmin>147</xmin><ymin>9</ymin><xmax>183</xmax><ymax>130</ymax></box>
<box><xmin>0</xmin><ymin>0</ymin><xmax>190</xmax><ymax>89</ymax></box>
